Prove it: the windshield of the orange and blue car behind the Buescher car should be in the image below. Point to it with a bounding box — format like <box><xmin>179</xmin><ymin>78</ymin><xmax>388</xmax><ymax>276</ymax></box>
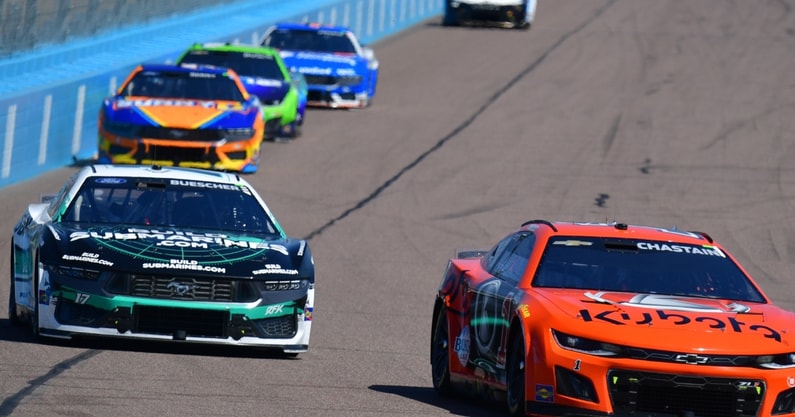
<box><xmin>121</xmin><ymin>70</ymin><xmax>245</xmax><ymax>102</ymax></box>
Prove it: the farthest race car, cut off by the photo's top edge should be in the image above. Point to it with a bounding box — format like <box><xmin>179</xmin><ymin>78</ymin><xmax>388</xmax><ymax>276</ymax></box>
<box><xmin>442</xmin><ymin>0</ymin><xmax>537</xmax><ymax>29</ymax></box>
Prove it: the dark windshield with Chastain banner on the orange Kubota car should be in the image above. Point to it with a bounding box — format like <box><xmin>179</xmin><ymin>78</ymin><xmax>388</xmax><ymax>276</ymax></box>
<box><xmin>532</xmin><ymin>237</ymin><xmax>765</xmax><ymax>302</ymax></box>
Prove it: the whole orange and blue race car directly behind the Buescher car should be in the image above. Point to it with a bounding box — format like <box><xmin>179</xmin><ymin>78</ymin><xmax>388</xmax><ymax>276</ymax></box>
<box><xmin>98</xmin><ymin>64</ymin><xmax>265</xmax><ymax>173</ymax></box>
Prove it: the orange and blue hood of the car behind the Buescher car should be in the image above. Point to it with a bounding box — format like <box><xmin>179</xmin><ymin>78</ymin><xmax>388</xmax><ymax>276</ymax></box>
<box><xmin>104</xmin><ymin>97</ymin><xmax>257</xmax><ymax>129</ymax></box>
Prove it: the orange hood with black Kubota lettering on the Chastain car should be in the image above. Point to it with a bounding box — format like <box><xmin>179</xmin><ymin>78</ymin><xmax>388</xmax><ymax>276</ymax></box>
<box><xmin>537</xmin><ymin>289</ymin><xmax>795</xmax><ymax>354</ymax></box>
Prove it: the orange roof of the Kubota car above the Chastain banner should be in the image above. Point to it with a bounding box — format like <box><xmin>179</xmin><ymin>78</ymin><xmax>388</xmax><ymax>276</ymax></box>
<box><xmin>521</xmin><ymin>220</ymin><xmax>716</xmax><ymax>245</ymax></box>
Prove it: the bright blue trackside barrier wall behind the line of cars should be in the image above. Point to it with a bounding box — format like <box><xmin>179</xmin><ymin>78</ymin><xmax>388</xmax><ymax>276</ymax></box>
<box><xmin>0</xmin><ymin>0</ymin><xmax>443</xmax><ymax>187</ymax></box>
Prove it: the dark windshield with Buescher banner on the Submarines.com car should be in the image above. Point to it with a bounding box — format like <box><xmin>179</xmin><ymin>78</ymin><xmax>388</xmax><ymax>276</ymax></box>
<box><xmin>60</xmin><ymin>177</ymin><xmax>279</xmax><ymax>234</ymax></box>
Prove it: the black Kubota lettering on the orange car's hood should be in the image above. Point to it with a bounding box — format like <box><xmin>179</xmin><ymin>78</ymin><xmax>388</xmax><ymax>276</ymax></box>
<box><xmin>579</xmin><ymin>309</ymin><xmax>781</xmax><ymax>342</ymax></box>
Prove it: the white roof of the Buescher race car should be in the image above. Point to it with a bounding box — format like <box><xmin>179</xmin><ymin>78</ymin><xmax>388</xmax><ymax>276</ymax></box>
<box><xmin>79</xmin><ymin>164</ymin><xmax>250</xmax><ymax>187</ymax></box>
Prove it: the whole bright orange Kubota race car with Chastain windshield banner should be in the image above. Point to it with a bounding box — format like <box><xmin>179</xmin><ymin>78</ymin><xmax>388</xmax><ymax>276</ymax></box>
<box><xmin>430</xmin><ymin>220</ymin><xmax>795</xmax><ymax>417</ymax></box>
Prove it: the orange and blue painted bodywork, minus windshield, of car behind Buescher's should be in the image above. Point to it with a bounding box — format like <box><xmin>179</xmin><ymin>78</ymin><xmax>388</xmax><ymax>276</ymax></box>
<box><xmin>99</xmin><ymin>66</ymin><xmax>265</xmax><ymax>172</ymax></box>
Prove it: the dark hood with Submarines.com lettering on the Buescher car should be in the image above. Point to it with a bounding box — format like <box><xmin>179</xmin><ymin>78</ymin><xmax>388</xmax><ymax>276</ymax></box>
<box><xmin>40</xmin><ymin>223</ymin><xmax>308</xmax><ymax>279</ymax></box>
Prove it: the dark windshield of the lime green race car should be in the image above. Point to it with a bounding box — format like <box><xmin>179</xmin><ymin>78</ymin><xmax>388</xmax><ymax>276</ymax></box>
<box><xmin>180</xmin><ymin>50</ymin><xmax>284</xmax><ymax>81</ymax></box>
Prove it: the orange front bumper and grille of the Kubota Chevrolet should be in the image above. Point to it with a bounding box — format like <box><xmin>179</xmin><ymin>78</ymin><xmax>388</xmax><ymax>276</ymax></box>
<box><xmin>525</xmin><ymin>336</ymin><xmax>795</xmax><ymax>417</ymax></box>
